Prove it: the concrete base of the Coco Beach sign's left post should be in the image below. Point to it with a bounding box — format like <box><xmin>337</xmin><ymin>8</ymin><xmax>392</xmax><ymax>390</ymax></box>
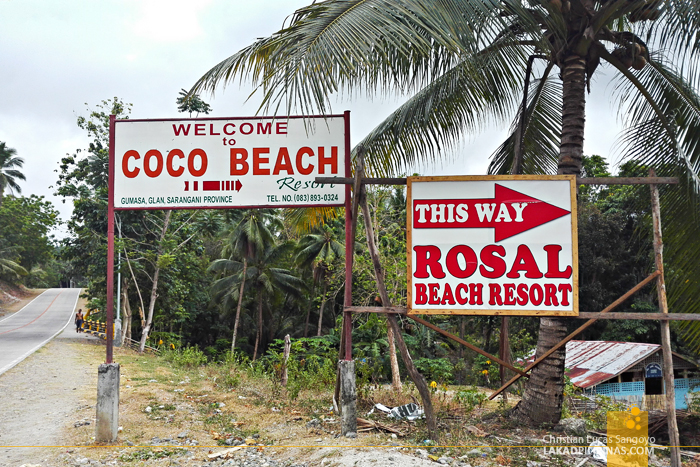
<box><xmin>95</xmin><ymin>363</ymin><xmax>119</xmax><ymax>444</ymax></box>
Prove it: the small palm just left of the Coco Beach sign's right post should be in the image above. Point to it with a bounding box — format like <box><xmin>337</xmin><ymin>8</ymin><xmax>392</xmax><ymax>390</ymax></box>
<box><xmin>296</xmin><ymin>224</ymin><xmax>345</xmax><ymax>337</ymax></box>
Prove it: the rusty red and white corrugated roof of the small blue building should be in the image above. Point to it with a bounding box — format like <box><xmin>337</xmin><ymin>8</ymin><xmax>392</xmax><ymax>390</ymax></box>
<box><xmin>564</xmin><ymin>340</ymin><xmax>661</xmax><ymax>388</ymax></box>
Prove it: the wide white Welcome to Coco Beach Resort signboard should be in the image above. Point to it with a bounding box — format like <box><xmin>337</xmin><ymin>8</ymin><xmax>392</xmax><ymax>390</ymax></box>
<box><xmin>110</xmin><ymin>114</ymin><xmax>350</xmax><ymax>209</ymax></box>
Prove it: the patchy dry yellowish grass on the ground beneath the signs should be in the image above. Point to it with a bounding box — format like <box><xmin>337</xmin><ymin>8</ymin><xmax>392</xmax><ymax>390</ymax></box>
<box><xmin>57</xmin><ymin>346</ymin><xmax>556</xmax><ymax>466</ymax></box>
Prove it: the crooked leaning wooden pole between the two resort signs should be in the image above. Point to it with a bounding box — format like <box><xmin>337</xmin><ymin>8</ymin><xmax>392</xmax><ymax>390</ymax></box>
<box><xmin>360</xmin><ymin>187</ymin><xmax>438</xmax><ymax>440</ymax></box>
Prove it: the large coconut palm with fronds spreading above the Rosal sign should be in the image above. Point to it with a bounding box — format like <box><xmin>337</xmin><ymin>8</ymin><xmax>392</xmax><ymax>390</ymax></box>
<box><xmin>191</xmin><ymin>0</ymin><xmax>700</xmax><ymax>423</ymax></box>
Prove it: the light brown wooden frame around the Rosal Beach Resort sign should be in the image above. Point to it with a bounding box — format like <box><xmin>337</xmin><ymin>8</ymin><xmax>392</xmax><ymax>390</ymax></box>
<box><xmin>406</xmin><ymin>175</ymin><xmax>579</xmax><ymax>317</ymax></box>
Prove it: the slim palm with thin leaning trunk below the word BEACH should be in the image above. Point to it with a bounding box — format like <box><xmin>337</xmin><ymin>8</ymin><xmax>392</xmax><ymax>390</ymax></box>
<box><xmin>209</xmin><ymin>209</ymin><xmax>282</xmax><ymax>352</ymax></box>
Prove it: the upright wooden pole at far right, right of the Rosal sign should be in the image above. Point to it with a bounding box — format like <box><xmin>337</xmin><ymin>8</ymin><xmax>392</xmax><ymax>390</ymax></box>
<box><xmin>649</xmin><ymin>169</ymin><xmax>681</xmax><ymax>467</ymax></box>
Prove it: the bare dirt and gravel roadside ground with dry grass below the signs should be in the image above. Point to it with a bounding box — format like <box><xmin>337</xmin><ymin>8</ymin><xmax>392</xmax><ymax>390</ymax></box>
<box><xmin>0</xmin><ymin>290</ymin><xmax>694</xmax><ymax>467</ymax></box>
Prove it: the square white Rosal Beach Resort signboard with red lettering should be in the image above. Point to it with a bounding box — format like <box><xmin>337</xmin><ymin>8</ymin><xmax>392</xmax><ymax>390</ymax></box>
<box><xmin>407</xmin><ymin>176</ymin><xmax>578</xmax><ymax>316</ymax></box>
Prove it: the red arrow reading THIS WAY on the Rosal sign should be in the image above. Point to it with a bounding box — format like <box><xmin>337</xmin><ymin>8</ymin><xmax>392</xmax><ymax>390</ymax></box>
<box><xmin>413</xmin><ymin>183</ymin><xmax>571</xmax><ymax>242</ymax></box>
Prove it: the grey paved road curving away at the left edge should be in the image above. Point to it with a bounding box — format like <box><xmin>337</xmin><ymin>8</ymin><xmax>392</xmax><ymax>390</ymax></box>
<box><xmin>0</xmin><ymin>289</ymin><xmax>80</xmax><ymax>375</ymax></box>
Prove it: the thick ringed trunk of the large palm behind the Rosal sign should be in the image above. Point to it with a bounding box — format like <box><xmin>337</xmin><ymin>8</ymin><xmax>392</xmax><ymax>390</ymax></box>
<box><xmin>513</xmin><ymin>54</ymin><xmax>586</xmax><ymax>425</ymax></box>
